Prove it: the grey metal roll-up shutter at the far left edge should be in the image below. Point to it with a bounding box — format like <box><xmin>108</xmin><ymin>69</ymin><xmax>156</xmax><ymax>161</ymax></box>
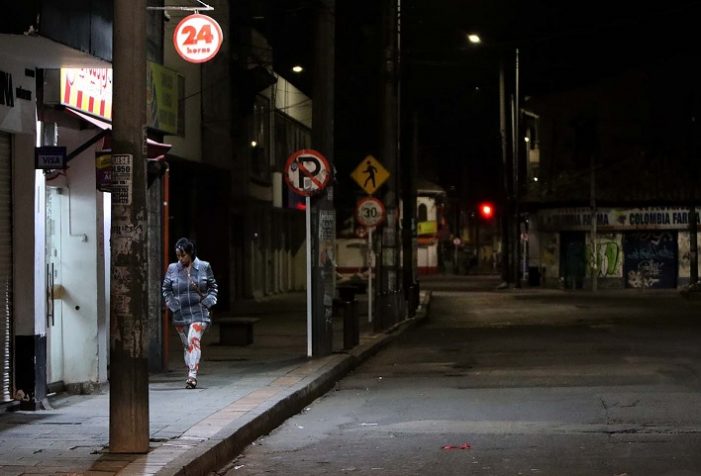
<box><xmin>0</xmin><ymin>132</ymin><xmax>12</xmax><ymax>402</ymax></box>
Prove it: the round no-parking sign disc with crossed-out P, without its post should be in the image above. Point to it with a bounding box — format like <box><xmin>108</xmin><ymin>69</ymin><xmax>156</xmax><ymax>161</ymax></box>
<box><xmin>284</xmin><ymin>149</ymin><xmax>331</xmax><ymax>197</ymax></box>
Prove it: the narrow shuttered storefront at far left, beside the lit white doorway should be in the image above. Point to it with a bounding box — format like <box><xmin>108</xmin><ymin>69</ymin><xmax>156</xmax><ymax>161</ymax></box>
<box><xmin>0</xmin><ymin>57</ymin><xmax>38</xmax><ymax>403</ymax></box>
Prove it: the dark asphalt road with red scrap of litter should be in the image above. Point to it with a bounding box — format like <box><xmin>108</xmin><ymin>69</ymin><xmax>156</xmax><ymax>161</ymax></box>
<box><xmin>218</xmin><ymin>277</ymin><xmax>701</xmax><ymax>476</ymax></box>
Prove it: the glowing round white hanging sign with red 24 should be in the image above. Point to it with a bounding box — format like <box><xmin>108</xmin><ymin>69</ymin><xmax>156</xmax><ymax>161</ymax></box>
<box><xmin>173</xmin><ymin>13</ymin><xmax>224</xmax><ymax>63</ymax></box>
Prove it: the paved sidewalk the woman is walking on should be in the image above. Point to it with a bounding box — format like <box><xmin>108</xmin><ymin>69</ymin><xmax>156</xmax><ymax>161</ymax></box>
<box><xmin>0</xmin><ymin>292</ymin><xmax>430</xmax><ymax>476</ymax></box>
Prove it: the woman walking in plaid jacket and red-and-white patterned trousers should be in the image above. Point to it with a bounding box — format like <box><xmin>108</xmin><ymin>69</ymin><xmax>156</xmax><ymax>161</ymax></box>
<box><xmin>161</xmin><ymin>238</ymin><xmax>218</xmax><ymax>388</ymax></box>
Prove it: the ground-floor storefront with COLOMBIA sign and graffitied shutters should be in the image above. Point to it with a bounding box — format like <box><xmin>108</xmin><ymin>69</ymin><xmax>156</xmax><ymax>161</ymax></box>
<box><xmin>529</xmin><ymin>207</ymin><xmax>698</xmax><ymax>289</ymax></box>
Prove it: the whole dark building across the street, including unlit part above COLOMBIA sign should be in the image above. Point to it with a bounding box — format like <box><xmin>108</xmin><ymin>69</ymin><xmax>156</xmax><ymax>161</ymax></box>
<box><xmin>520</xmin><ymin>57</ymin><xmax>701</xmax><ymax>289</ymax></box>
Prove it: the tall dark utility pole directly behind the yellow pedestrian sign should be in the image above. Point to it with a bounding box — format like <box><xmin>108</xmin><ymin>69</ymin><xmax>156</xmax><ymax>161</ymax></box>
<box><xmin>374</xmin><ymin>0</ymin><xmax>400</xmax><ymax>329</ymax></box>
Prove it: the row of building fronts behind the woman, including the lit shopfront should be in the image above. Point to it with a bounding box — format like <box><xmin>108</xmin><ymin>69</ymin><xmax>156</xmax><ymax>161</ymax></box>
<box><xmin>0</xmin><ymin>0</ymin><xmax>311</xmax><ymax>409</ymax></box>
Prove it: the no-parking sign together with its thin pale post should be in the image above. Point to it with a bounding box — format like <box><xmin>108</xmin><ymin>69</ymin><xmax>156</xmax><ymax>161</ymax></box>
<box><xmin>283</xmin><ymin>149</ymin><xmax>332</xmax><ymax>357</ymax></box>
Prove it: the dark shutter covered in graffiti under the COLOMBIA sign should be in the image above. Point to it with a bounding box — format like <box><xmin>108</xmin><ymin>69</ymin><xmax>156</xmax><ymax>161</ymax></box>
<box><xmin>623</xmin><ymin>231</ymin><xmax>677</xmax><ymax>288</ymax></box>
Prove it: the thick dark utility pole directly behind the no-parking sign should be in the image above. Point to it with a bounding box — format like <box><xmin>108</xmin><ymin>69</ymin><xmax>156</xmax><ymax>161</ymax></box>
<box><xmin>307</xmin><ymin>0</ymin><xmax>336</xmax><ymax>357</ymax></box>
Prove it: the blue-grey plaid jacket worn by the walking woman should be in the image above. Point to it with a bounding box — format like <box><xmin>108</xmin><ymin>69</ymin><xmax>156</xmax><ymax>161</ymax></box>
<box><xmin>161</xmin><ymin>258</ymin><xmax>219</xmax><ymax>325</ymax></box>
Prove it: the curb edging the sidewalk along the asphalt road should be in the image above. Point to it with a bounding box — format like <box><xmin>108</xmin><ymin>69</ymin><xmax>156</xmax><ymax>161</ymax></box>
<box><xmin>156</xmin><ymin>291</ymin><xmax>431</xmax><ymax>476</ymax></box>
